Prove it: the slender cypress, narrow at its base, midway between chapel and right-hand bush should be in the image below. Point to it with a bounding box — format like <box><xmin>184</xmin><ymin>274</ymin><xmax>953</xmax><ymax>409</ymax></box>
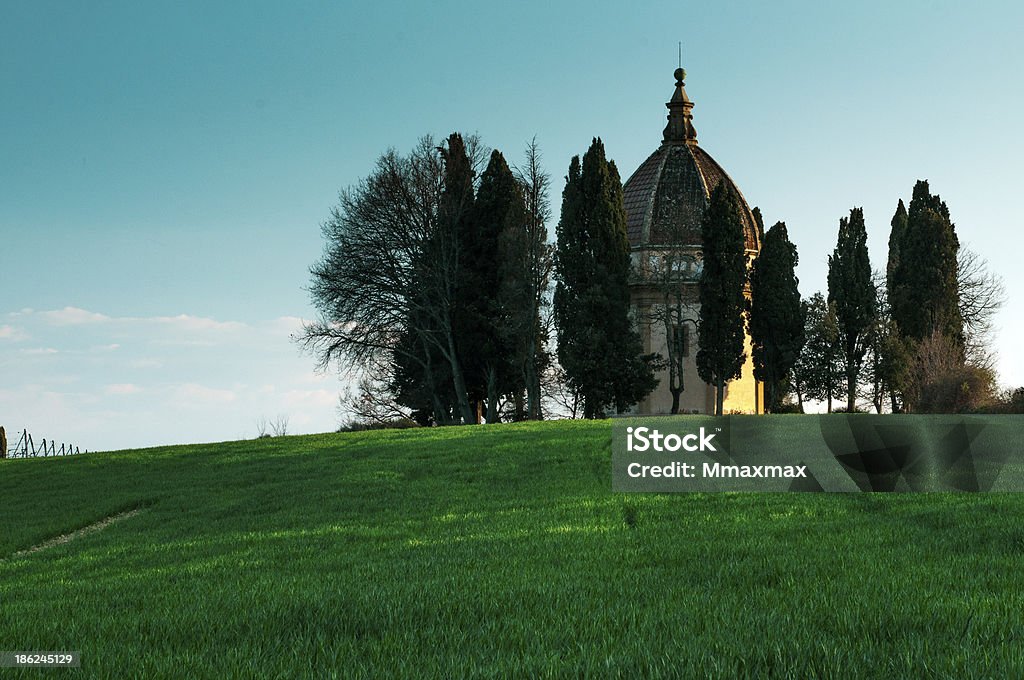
<box><xmin>828</xmin><ymin>208</ymin><xmax>877</xmax><ymax>413</ymax></box>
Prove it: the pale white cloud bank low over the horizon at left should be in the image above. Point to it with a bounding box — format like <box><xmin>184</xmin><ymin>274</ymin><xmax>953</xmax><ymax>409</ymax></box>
<box><xmin>0</xmin><ymin>306</ymin><xmax>342</xmax><ymax>449</ymax></box>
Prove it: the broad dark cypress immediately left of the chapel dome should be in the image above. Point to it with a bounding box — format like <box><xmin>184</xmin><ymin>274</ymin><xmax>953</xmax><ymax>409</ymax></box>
<box><xmin>554</xmin><ymin>138</ymin><xmax>657</xmax><ymax>418</ymax></box>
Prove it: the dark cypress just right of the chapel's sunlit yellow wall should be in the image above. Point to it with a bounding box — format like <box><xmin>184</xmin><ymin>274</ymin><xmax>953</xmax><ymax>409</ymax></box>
<box><xmin>750</xmin><ymin>222</ymin><xmax>804</xmax><ymax>411</ymax></box>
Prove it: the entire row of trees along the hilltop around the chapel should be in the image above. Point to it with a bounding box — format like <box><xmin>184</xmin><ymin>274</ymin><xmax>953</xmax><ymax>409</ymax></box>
<box><xmin>300</xmin><ymin>129</ymin><xmax>1001</xmax><ymax>424</ymax></box>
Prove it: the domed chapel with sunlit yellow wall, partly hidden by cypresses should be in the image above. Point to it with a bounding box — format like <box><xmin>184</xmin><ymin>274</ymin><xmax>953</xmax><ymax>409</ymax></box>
<box><xmin>624</xmin><ymin>69</ymin><xmax>764</xmax><ymax>415</ymax></box>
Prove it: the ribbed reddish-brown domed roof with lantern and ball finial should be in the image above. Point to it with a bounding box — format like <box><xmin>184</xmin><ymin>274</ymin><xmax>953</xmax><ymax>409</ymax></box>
<box><xmin>623</xmin><ymin>69</ymin><xmax>762</xmax><ymax>251</ymax></box>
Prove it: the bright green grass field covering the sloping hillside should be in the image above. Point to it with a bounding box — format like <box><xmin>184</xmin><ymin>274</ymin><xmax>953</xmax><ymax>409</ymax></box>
<box><xmin>0</xmin><ymin>417</ymin><xmax>1024</xmax><ymax>678</ymax></box>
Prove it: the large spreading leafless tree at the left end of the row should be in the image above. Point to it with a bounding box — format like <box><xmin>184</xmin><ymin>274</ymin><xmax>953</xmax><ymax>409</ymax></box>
<box><xmin>298</xmin><ymin>135</ymin><xmax>483</xmax><ymax>423</ymax></box>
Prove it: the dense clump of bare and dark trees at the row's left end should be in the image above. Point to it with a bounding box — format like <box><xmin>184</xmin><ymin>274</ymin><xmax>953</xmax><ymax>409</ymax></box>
<box><xmin>300</xmin><ymin>134</ymin><xmax>552</xmax><ymax>424</ymax></box>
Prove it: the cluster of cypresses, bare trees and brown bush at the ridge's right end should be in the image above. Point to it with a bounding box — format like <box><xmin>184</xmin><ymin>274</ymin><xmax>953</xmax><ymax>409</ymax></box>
<box><xmin>790</xmin><ymin>181</ymin><xmax>1005</xmax><ymax>413</ymax></box>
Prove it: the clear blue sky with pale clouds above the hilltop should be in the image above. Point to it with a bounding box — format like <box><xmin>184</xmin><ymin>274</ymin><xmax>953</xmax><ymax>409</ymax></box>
<box><xmin>0</xmin><ymin>2</ymin><xmax>1024</xmax><ymax>449</ymax></box>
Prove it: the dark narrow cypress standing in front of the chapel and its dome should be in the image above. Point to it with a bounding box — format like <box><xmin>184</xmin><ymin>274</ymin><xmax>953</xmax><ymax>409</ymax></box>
<box><xmin>696</xmin><ymin>182</ymin><xmax>746</xmax><ymax>416</ymax></box>
